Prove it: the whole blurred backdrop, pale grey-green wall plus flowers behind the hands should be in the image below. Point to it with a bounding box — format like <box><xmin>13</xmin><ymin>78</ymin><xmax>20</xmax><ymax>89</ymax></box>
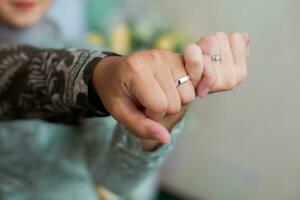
<box><xmin>50</xmin><ymin>0</ymin><xmax>300</xmax><ymax>200</ymax></box>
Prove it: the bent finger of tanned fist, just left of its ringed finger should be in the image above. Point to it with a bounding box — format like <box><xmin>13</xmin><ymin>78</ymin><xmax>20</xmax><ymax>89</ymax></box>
<box><xmin>155</xmin><ymin>66</ymin><xmax>181</xmax><ymax>115</ymax></box>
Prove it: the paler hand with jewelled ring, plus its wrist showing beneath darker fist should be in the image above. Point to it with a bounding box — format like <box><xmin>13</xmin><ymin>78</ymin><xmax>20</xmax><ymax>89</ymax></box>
<box><xmin>142</xmin><ymin>33</ymin><xmax>250</xmax><ymax>150</ymax></box>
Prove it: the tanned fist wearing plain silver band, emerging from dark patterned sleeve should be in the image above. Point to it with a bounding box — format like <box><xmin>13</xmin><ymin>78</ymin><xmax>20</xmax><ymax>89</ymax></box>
<box><xmin>93</xmin><ymin>50</ymin><xmax>203</xmax><ymax>143</ymax></box>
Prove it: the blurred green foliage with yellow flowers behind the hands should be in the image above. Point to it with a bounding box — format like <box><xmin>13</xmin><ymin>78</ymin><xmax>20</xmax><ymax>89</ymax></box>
<box><xmin>86</xmin><ymin>0</ymin><xmax>188</xmax><ymax>54</ymax></box>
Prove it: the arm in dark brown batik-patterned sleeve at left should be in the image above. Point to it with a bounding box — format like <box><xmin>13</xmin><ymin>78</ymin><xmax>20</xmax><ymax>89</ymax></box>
<box><xmin>0</xmin><ymin>45</ymin><xmax>112</xmax><ymax>120</ymax></box>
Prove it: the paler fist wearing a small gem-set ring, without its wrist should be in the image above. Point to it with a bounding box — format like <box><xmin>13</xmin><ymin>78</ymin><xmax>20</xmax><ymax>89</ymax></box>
<box><xmin>184</xmin><ymin>32</ymin><xmax>250</xmax><ymax>98</ymax></box>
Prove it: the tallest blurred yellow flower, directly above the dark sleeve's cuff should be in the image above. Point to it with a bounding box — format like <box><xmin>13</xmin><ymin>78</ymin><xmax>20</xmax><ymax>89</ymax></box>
<box><xmin>111</xmin><ymin>23</ymin><xmax>131</xmax><ymax>54</ymax></box>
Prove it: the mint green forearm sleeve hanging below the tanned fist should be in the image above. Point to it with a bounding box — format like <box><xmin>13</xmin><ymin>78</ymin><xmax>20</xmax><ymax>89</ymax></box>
<box><xmin>82</xmin><ymin>117</ymin><xmax>184</xmax><ymax>195</ymax></box>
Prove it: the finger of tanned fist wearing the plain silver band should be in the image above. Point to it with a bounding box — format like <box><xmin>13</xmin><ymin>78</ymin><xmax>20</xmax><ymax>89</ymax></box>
<box><xmin>171</xmin><ymin>54</ymin><xmax>195</xmax><ymax>105</ymax></box>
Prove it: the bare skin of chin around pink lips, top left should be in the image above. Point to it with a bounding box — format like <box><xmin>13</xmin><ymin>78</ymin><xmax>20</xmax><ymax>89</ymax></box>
<box><xmin>0</xmin><ymin>0</ymin><xmax>52</xmax><ymax>28</ymax></box>
